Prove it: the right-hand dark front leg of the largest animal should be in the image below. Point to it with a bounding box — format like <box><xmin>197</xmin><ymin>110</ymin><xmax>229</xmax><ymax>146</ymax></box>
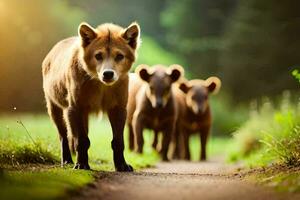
<box><xmin>108</xmin><ymin>107</ymin><xmax>133</xmax><ymax>172</ymax></box>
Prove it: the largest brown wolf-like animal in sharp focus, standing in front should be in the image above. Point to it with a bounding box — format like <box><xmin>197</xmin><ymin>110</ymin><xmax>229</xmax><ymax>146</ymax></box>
<box><xmin>42</xmin><ymin>23</ymin><xmax>140</xmax><ymax>171</ymax></box>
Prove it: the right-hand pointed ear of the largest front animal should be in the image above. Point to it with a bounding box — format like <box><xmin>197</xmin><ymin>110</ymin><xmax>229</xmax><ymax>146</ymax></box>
<box><xmin>122</xmin><ymin>22</ymin><xmax>140</xmax><ymax>49</ymax></box>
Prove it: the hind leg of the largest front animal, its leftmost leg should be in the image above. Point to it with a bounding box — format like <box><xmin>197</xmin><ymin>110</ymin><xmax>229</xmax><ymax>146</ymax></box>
<box><xmin>47</xmin><ymin>100</ymin><xmax>73</xmax><ymax>165</ymax></box>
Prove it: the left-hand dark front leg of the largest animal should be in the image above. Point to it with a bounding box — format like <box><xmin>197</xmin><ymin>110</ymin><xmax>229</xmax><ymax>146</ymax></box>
<box><xmin>65</xmin><ymin>107</ymin><xmax>90</xmax><ymax>169</ymax></box>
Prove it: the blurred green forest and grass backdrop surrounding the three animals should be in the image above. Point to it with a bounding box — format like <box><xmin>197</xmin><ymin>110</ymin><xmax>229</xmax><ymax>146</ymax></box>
<box><xmin>0</xmin><ymin>0</ymin><xmax>300</xmax><ymax>196</ymax></box>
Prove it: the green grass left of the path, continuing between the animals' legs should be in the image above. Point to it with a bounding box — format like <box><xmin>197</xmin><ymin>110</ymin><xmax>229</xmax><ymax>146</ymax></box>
<box><xmin>0</xmin><ymin>114</ymin><xmax>230</xmax><ymax>199</ymax></box>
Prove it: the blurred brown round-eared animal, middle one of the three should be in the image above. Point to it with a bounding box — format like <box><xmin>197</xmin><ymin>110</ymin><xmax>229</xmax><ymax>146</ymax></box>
<box><xmin>127</xmin><ymin>65</ymin><xmax>183</xmax><ymax>160</ymax></box>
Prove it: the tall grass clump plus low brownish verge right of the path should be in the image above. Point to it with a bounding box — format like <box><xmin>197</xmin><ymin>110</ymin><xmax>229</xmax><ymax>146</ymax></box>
<box><xmin>229</xmin><ymin>93</ymin><xmax>300</xmax><ymax>191</ymax></box>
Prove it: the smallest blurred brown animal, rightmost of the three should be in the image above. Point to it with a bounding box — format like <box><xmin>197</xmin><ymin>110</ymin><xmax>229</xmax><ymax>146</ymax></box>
<box><xmin>174</xmin><ymin>77</ymin><xmax>221</xmax><ymax>160</ymax></box>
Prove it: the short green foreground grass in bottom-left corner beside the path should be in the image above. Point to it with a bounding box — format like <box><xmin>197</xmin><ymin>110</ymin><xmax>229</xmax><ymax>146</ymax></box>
<box><xmin>0</xmin><ymin>168</ymin><xmax>94</xmax><ymax>200</ymax></box>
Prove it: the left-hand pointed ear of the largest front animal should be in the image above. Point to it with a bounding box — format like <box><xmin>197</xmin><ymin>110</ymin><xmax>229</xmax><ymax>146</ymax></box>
<box><xmin>78</xmin><ymin>22</ymin><xmax>97</xmax><ymax>47</ymax></box>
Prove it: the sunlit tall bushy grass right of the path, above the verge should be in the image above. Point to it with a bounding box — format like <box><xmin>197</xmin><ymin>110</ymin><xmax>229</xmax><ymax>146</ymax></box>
<box><xmin>231</xmin><ymin>95</ymin><xmax>300</xmax><ymax>166</ymax></box>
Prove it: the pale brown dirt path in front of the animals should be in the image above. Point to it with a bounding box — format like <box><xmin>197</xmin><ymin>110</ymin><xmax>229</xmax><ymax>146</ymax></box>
<box><xmin>72</xmin><ymin>161</ymin><xmax>300</xmax><ymax>200</ymax></box>
